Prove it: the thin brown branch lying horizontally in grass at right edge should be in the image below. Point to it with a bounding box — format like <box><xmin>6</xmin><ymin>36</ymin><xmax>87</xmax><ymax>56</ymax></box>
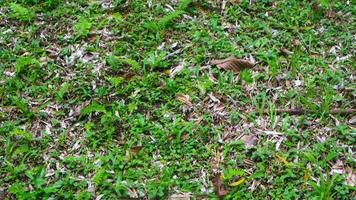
<box><xmin>263</xmin><ymin>108</ymin><xmax>356</xmax><ymax>115</ymax></box>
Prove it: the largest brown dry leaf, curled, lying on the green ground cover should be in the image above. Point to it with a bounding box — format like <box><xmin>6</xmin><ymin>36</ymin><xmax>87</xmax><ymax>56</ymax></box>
<box><xmin>211</xmin><ymin>56</ymin><xmax>255</xmax><ymax>72</ymax></box>
